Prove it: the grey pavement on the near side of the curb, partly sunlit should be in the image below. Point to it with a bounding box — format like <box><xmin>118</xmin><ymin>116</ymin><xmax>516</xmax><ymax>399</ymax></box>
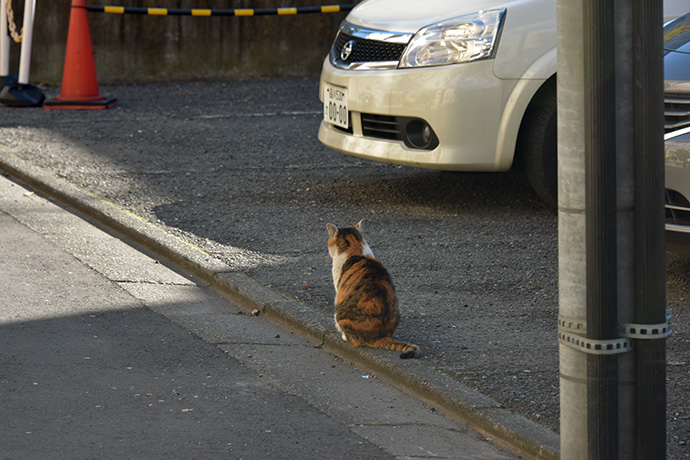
<box><xmin>0</xmin><ymin>177</ymin><xmax>516</xmax><ymax>459</ymax></box>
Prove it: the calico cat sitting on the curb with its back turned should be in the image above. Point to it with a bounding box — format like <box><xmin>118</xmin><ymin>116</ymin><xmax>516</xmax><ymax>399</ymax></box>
<box><xmin>326</xmin><ymin>221</ymin><xmax>421</xmax><ymax>359</ymax></box>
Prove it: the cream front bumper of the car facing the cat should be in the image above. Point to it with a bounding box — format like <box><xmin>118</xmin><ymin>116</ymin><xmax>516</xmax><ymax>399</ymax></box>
<box><xmin>319</xmin><ymin>58</ymin><xmax>528</xmax><ymax>171</ymax></box>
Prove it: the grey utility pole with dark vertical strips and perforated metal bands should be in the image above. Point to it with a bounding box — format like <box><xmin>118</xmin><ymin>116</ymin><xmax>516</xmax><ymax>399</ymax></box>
<box><xmin>558</xmin><ymin>0</ymin><xmax>669</xmax><ymax>460</ymax></box>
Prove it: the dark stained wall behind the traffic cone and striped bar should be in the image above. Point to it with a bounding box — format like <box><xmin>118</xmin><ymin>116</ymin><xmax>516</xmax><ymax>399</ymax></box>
<box><xmin>10</xmin><ymin>0</ymin><xmax>346</xmax><ymax>84</ymax></box>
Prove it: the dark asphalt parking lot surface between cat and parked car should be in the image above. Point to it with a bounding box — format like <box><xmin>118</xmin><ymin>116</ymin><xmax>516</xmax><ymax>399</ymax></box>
<box><xmin>0</xmin><ymin>79</ymin><xmax>690</xmax><ymax>458</ymax></box>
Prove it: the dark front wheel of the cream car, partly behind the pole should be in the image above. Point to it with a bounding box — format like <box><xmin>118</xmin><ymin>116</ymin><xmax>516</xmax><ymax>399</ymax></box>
<box><xmin>518</xmin><ymin>85</ymin><xmax>558</xmax><ymax>210</ymax></box>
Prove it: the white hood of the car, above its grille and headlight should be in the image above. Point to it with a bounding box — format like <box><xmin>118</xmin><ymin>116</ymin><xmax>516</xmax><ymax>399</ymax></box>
<box><xmin>347</xmin><ymin>0</ymin><xmax>524</xmax><ymax>33</ymax></box>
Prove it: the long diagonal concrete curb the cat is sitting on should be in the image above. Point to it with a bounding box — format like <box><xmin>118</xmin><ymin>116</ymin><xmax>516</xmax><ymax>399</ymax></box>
<box><xmin>0</xmin><ymin>154</ymin><xmax>560</xmax><ymax>459</ymax></box>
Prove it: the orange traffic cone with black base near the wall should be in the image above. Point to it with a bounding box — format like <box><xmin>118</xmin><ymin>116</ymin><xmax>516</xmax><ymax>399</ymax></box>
<box><xmin>43</xmin><ymin>0</ymin><xmax>117</xmax><ymax>109</ymax></box>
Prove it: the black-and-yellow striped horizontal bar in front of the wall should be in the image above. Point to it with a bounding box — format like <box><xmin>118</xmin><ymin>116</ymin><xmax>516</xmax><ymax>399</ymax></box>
<box><xmin>81</xmin><ymin>4</ymin><xmax>355</xmax><ymax>16</ymax></box>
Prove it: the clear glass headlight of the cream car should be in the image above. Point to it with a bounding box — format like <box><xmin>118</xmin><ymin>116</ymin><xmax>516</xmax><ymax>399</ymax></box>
<box><xmin>399</xmin><ymin>9</ymin><xmax>505</xmax><ymax>68</ymax></box>
